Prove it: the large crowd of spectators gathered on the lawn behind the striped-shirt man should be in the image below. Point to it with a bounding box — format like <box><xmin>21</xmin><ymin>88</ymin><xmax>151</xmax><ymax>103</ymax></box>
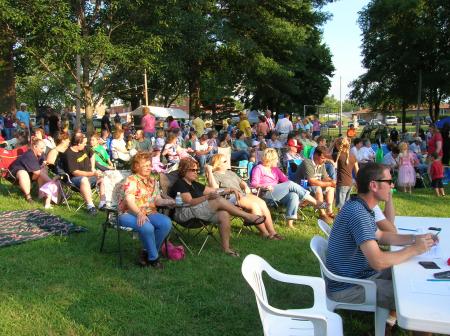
<box><xmin>1</xmin><ymin>109</ymin><xmax>444</xmax><ymax>267</ymax></box>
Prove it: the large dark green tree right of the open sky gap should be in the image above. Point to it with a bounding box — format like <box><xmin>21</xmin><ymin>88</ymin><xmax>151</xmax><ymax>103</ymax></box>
<box><xmin>351</xmin><ymin>0</ymin><xmax>450</xmax><ymax>127</ymax></box>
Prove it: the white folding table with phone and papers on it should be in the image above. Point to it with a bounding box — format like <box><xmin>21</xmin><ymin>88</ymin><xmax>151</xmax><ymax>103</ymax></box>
<box><xmin>391</xmin><ymin>216</ymin><xmax>450</xmax><ymax>334</ymax></box>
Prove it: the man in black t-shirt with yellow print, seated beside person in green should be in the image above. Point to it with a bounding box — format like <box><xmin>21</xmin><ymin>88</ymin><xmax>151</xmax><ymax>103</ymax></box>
<box><xmin>64</xmin><ymin>133</ymin><xmax>105</xmax><ymax>216</ymax></box>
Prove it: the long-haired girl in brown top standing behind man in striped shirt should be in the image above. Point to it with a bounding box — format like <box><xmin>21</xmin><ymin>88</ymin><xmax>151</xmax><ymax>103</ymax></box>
<box><xmin>333</xmin><ymin>137</ymin><xmax>359</xmax><ymax>209</ymax></box>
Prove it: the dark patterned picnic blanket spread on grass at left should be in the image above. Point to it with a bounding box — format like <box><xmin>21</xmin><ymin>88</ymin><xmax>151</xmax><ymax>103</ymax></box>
<box><xmin>0</xmin><ymin>210</ymin><xmax>87</xmax><ymax>247</ymax></box>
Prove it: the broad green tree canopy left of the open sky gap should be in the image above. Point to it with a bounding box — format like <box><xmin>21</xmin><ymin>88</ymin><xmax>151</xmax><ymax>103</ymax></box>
<box><xmin>0</xmin><ymin>0</ymin><xmax>334</xmax><ymax>132</ymax></box>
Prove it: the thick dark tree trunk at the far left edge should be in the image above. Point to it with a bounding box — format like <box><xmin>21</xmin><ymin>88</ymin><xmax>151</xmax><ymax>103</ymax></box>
<box><xmin>0</xmin><ymin>28</ymin><xmax>16</xmax><ymax>113</ymax></box>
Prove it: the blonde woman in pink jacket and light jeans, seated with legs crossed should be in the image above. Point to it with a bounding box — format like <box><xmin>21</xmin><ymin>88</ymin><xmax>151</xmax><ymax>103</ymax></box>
<box><xmin>251</xmin><ymin>148</ymin><xmax>328</xmax><ymax>228</ymax></box>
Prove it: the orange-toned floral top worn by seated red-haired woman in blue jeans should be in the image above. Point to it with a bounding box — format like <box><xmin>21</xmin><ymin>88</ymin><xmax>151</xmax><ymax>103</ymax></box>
<box><xmin>118</xmin><ymin>175</ymin><xmax>160</xmax><ymax>215</ymax></box>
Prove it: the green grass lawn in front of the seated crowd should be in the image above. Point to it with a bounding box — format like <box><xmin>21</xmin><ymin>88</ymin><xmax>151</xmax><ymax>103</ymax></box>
<box><xmin>0</xmin><ymin>186</ymin><xmax>450</xmax><ymax>335</ymax></box>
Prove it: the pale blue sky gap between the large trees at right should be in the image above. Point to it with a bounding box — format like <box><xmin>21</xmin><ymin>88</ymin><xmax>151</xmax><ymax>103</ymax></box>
<box><xmin>323</xmin><ymin>0</ymin><xmax>369</xmax><ymax>100</ymax></box>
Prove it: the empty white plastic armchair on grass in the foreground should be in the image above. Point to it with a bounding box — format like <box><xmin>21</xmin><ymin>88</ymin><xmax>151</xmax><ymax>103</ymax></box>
<box><xmin>242</xmin><ymin>254</ymin><xmax>343</xmax><ymax>336</ymax></box>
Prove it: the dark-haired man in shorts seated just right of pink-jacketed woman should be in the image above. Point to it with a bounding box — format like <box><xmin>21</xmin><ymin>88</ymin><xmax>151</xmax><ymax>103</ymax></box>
<box><xmin>294</xmin><ymin>146</ymin><xmax>336</xmax><ymax>224</ymax></box>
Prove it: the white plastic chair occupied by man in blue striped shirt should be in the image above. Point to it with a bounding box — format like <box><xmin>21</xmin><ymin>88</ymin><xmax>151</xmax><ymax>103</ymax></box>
<box><xmin>310</xmin><ymin>236</ymin><xmax>389</xmax><ymax>336</ymax></box>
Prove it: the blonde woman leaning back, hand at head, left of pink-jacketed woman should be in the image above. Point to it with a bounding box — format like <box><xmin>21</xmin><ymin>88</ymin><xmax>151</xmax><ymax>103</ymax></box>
<box><xmin>206</xmin><ymin>154</ymin><xmax>283</xmax><ymax>240</ymax></box>
